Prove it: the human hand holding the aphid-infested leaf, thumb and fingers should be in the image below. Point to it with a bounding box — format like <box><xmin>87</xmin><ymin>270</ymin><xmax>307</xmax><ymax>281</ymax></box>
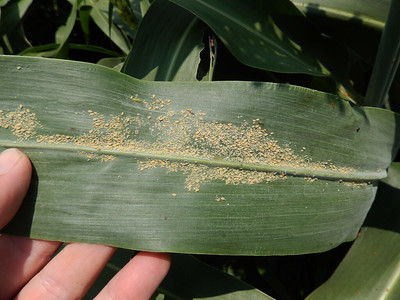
<box><xmin>0</xmin><ymin>149</ymin><xmax>170</xmax><ymax>299</ymax></box>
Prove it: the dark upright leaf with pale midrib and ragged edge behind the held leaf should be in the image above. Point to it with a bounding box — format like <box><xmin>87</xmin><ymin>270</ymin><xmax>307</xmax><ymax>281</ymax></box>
<box><xmin>123</xmin><ymin>0</ymin><xmax>206</xmax><ymax>81</ymax></box>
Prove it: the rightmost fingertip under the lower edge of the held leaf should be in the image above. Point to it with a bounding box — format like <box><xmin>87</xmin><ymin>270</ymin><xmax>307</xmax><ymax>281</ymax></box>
<box><xmin>95</xmin><ymin>252</ymin><xmax>171</xmax><ymax>300</ymax></box>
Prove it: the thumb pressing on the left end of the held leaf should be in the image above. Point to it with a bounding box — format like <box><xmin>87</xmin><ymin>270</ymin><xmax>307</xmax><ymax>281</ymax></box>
<box><xmin>0</xmin><ymin>149</ymin><xmax>32</xmax><ymax>228</ymax></box>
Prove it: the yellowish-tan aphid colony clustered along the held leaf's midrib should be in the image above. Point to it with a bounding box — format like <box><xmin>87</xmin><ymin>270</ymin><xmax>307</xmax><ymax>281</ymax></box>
<box><xmin>0</xmin><ymin>95</ymin><xmax>352</xmax><ymax>191</ymax></box>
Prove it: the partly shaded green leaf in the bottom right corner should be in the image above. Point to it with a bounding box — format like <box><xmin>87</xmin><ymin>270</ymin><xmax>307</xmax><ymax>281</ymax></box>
<box><xmin>307</xmin><ymin>184</ymin><xmax>400</xmax><ymax>300</ymax></box>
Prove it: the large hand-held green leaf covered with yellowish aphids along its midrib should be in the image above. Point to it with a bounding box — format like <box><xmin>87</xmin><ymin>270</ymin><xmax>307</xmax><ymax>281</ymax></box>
<box><xmin>0</xmin><ymin>56</ymin><xmax>399</xmax><ymax>255</ymax></box>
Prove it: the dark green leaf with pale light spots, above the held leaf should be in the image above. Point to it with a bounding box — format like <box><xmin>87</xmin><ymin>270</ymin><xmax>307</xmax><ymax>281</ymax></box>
<box><xmin>169</xmin><ymin>0</ymin><xmax>347</xmax><ymax>77</ymax></box>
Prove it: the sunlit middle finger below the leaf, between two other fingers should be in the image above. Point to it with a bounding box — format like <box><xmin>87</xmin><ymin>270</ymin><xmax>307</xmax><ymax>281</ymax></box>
<box><xmin>15</xmin><ymin>244</ymin><xmax>115</xmax><ymax>300</ymax></box>
